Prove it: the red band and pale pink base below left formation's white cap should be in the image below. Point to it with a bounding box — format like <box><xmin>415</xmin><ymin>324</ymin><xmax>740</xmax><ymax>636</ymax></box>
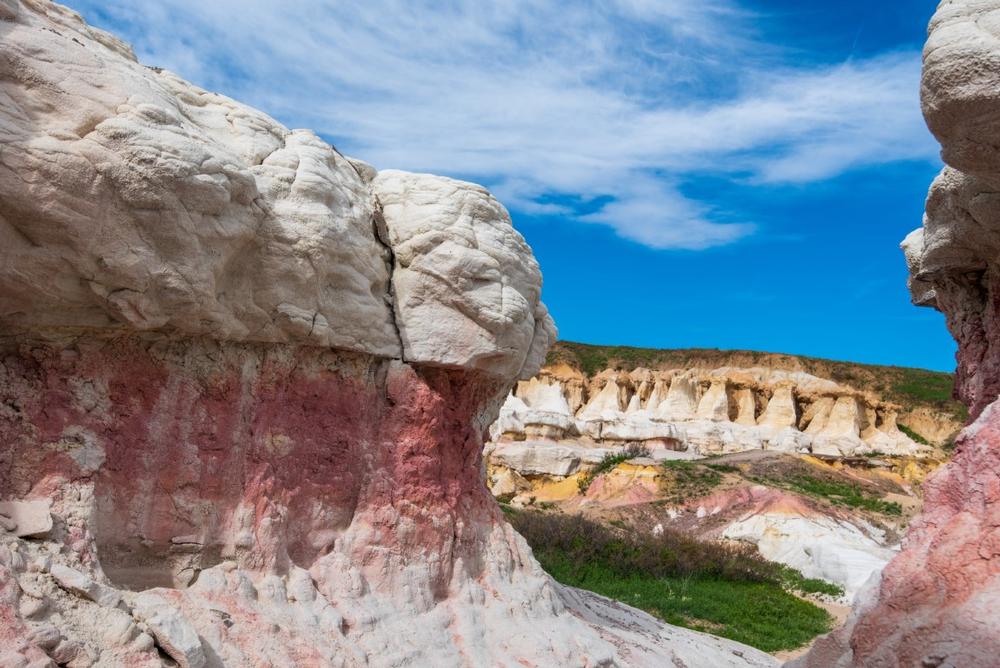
<box><xmin>0</xmin><ymin>332</ymin><xmax>788</xmax><ymax>668</ymax></box>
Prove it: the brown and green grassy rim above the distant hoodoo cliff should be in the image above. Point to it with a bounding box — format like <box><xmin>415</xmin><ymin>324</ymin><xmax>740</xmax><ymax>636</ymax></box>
<box><xmin>546</xmin><ymin>341</ymin><xmax>968</xmax><ymax>421</ymax></box>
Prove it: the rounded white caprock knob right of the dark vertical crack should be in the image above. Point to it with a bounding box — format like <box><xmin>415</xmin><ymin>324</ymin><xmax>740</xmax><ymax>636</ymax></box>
<box><xmin>372</xmin><ymin>170</ymin><xmax>555</xmax><ymax>377</ymax></box>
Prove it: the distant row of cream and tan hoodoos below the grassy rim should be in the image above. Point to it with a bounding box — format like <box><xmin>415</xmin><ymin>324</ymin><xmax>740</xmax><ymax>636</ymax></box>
<box><xmin>490</xmin><ymin>364</ymin><xmax>929</xmax><ymax>457</ymax></box>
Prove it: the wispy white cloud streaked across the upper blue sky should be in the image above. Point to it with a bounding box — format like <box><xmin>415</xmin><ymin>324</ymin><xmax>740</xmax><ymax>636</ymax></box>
<box><xmin>71</xmin><ymin>0</ymin><xmax>936</xmax><ymax>249</ymax></box>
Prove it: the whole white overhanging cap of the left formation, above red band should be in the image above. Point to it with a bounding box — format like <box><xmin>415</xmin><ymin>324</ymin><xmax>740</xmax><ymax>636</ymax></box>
<box><xmin>0</xmin><ymin>3</ymin><xmax>555</xmax><ymax>377</ymax></box>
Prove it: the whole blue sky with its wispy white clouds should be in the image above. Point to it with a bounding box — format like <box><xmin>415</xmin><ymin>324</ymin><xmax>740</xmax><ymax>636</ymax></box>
<box><xmin>68</xmin><ymin>0</ymin><xmax>954</xmax><ymax>370</ymax></box>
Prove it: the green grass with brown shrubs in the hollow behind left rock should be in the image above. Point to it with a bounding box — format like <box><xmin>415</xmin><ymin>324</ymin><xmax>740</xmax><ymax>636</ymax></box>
<box><xmin>510</xmin><ymin>512</ymin><xmax>833</xmax><ymax>652</ymax></box>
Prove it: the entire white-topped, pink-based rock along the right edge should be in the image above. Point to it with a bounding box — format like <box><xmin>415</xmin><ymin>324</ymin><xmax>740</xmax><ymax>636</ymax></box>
<box><xmin>797</xmin><ymin>0</ymin><xmax>1000</xmax><ymax>668</ymax></box>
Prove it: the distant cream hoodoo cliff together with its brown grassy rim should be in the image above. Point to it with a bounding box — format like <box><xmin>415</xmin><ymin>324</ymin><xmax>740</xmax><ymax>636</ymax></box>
<box><xmin>490</xmin><ymin>343</ymin><xmax>964</xmax><ymax>457</ymax></box>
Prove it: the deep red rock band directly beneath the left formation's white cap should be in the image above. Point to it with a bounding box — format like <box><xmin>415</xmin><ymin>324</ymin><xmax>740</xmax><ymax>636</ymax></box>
<box><xmin>0</xmin><ymin>336</ymin><xmax>499</xmax><ymax>588</ymax></box>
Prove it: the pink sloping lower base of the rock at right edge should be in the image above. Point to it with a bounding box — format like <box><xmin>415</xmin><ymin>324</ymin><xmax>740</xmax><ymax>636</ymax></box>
<box><xmin>792</xmin><ymin>403</ymin><xmax>1000</xmax><ymax>668</ymax></box>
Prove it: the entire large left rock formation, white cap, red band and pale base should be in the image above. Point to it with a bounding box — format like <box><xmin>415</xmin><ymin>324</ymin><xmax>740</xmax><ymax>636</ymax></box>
<box><xmin>0</xmin><ymin>0</ymin><xmax>774</xmax><ymax>668</ymax></box>
